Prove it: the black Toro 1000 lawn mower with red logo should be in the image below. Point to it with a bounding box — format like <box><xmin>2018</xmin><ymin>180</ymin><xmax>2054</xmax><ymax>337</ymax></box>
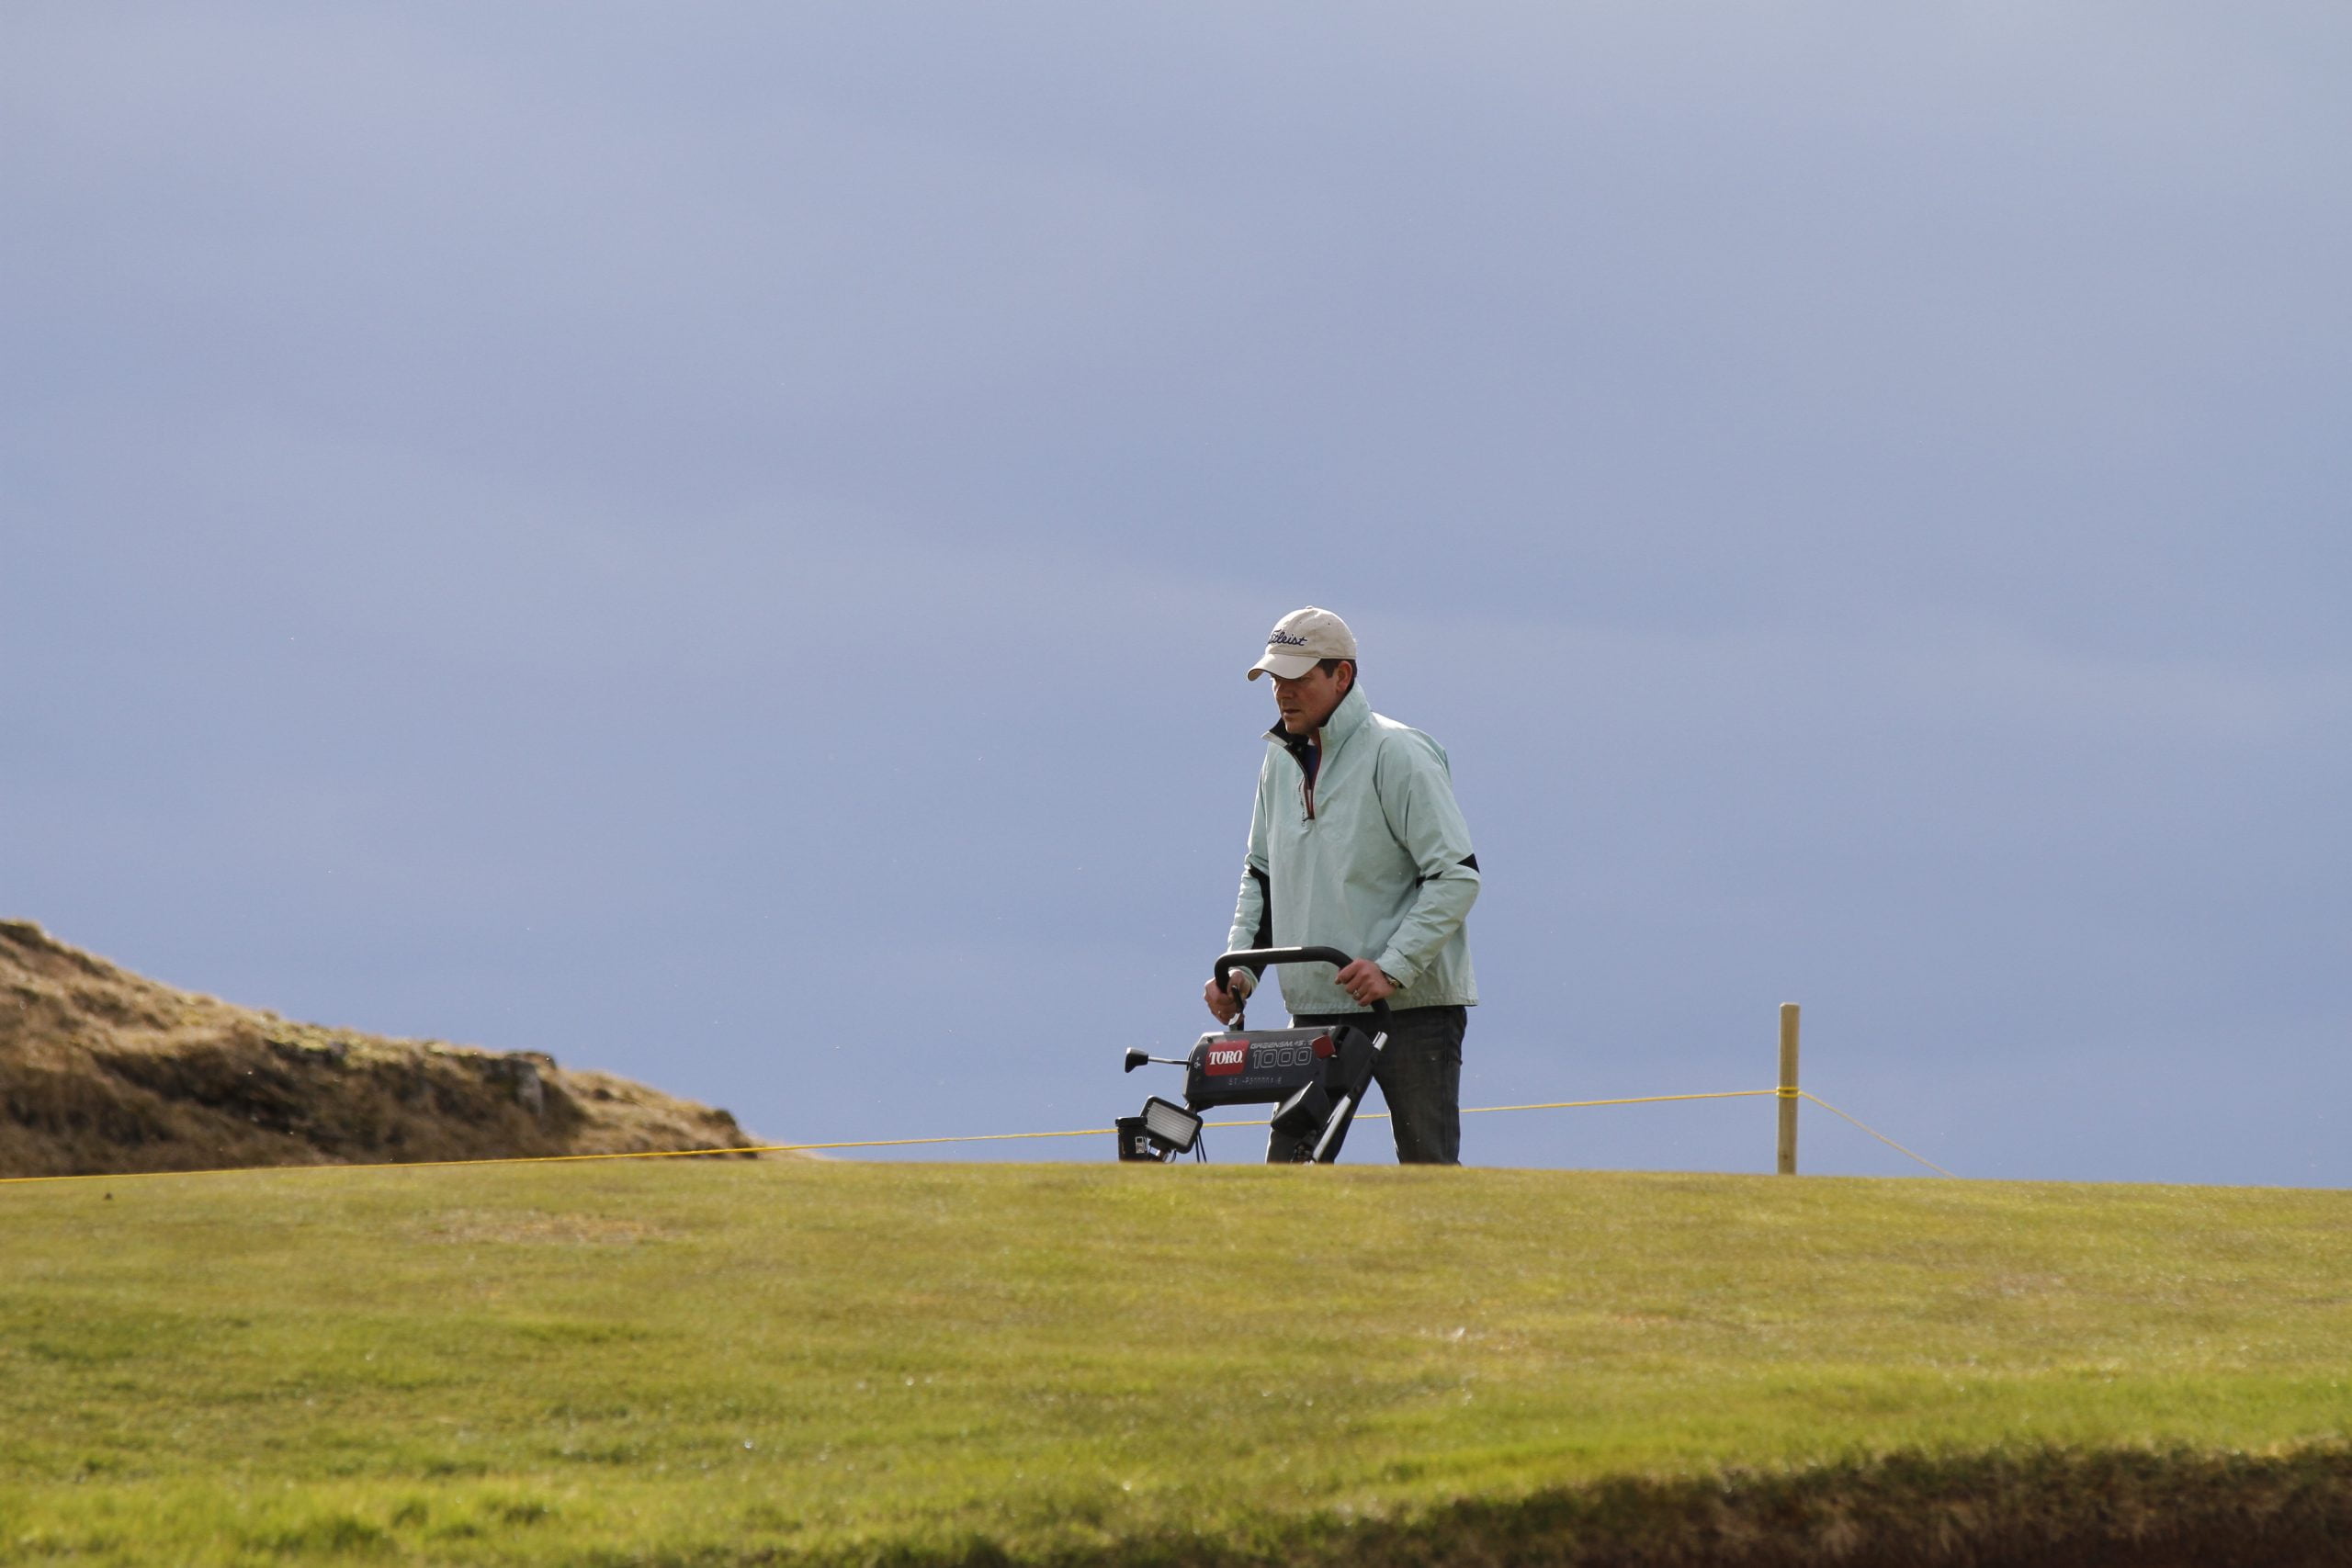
<box><xmin>1117</xmin><ymin>947</ymin><xmax>1387</xmax><ymax>1166</ymax></box>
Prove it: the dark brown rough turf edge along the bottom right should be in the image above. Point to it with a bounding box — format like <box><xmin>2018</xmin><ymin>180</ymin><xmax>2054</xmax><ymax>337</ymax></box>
<box><xmin>780</xmin><ymin>1443</ymin><xmax>2352</xmax><ymax>1568</ymax></box>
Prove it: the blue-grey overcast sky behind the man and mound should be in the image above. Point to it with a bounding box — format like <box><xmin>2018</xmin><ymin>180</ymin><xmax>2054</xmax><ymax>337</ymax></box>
<box><xmin>0</xmin><ymin>3</ymin><xmax>2352</xmax><ymax>1185</ymax></box>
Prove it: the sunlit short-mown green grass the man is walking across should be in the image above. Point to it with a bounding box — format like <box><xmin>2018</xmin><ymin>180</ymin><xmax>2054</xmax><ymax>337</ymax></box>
<box><xmin>0</xmin><ymin>1159</ymin><xmax>2352</xmax><ymax>1563</ymax></box>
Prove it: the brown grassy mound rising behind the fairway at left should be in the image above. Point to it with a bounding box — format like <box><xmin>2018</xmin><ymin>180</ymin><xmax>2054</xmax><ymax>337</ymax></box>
<box><xmin>0</xmin><ymin>921</ymin><xmax>751</xmax><ymax>1176</ymax></box>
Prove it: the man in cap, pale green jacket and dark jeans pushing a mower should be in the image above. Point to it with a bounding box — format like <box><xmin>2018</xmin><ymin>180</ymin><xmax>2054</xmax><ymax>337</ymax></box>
<box><xmin>1206</xmin><ymin>604</ymin><xmax>1479</xmax><ymax>1166</ymax></box>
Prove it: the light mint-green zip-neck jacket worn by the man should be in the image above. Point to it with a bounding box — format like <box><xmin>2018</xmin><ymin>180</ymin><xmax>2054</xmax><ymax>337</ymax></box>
<box><xmin>1226</xmin><ymin>689</ymin><xmax>1479</xmax><ymax>1013</ymax></box>
